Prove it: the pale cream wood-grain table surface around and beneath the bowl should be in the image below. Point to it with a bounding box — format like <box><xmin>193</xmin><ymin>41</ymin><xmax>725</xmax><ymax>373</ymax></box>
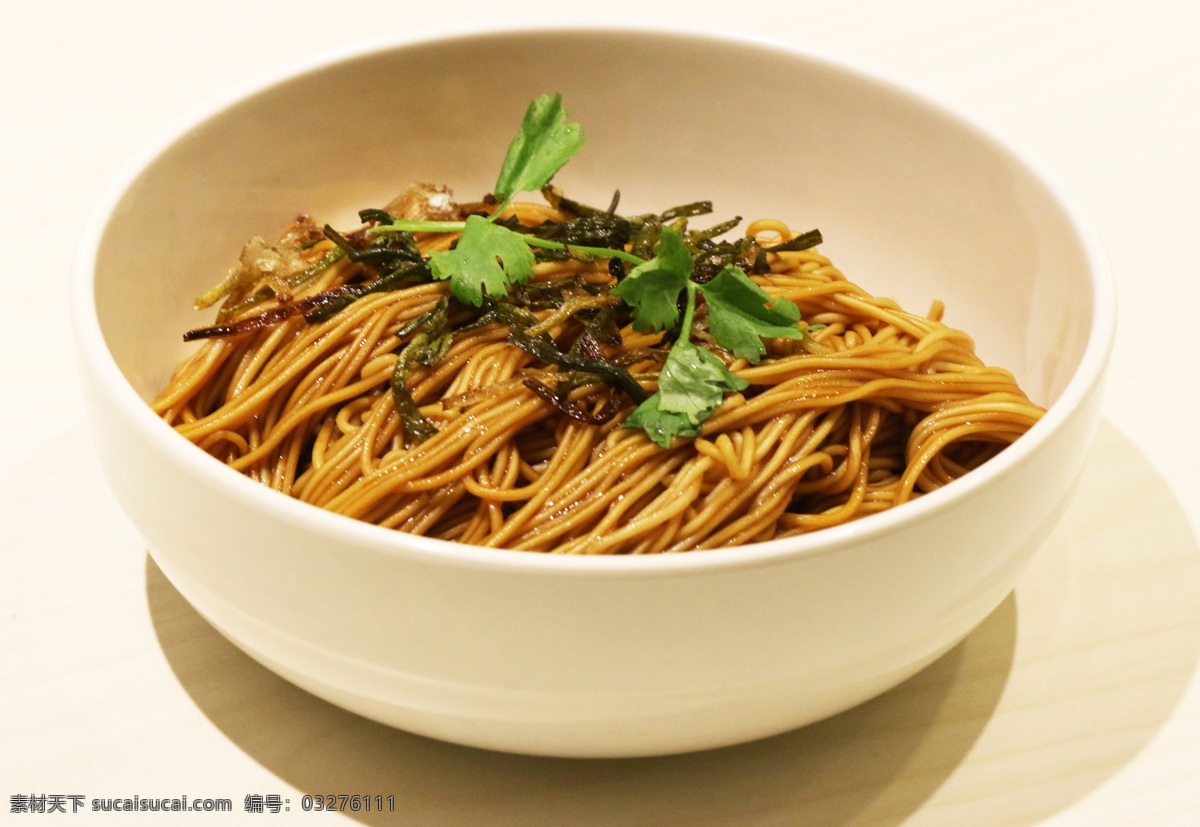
<box><xmin>0</xmin><ymin>0</ymin><xmax>1200</xmax><ymax>827</ymax></box>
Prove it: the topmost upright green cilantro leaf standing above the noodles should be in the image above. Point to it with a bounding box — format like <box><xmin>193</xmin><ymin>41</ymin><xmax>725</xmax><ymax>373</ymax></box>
<box><xmin>496</xmin><ymin>95</ymin><xmax>584</xmax><ymax>202</ymax></box>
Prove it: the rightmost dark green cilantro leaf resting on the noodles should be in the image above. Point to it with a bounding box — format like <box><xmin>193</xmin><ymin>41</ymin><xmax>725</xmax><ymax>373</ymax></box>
<box><xmin>696</xmin><ymin>264</ymin><xmax>804</xmax><ymax>364</ymax></box>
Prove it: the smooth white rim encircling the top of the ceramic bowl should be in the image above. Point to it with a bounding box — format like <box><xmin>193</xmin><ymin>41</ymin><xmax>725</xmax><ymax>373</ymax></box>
<box><xmin>70</xmin><ymin>18</ymin><xmax>1116</xmax><ymax>577</ymax></box>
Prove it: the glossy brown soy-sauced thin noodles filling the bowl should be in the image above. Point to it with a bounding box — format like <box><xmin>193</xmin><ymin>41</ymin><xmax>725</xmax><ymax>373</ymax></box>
<box><xmin>154</xmin><ymin>196</ymin><xmax>1043</xmax><ymax>555</ymax></box>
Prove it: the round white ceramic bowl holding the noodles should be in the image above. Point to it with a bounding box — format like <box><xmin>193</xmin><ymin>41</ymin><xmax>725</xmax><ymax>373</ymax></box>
<box><xmin>73</xmin><ymin>21</ymin><xmax>1114</xmax><ymax>756</ymax></box>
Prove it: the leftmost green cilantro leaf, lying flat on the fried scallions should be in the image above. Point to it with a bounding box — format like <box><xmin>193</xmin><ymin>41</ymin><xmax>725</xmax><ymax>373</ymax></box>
<box><xmin>430</xmin><ymin>215</ymin><xmax>534</xmax><ymax>307</ymax></box>
